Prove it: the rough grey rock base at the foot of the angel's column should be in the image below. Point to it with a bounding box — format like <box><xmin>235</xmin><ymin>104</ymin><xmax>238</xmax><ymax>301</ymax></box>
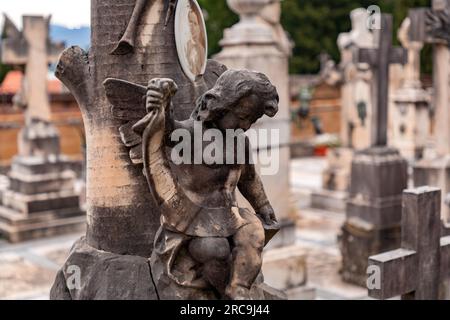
<box><xmin>50</xmin><ymin>237</ymin><xmax>286</xmax><ymax>300</ymax></box>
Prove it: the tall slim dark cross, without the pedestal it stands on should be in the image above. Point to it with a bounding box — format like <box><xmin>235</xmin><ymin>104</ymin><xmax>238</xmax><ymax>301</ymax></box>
<box><xmin>357</xmin><ymin>14</ymin><xmax>407</xmax><ymax>147</ymax></box>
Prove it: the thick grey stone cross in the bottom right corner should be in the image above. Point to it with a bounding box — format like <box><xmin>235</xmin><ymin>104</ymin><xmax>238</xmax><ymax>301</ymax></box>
<box><xmin>368</xmin><ymin>187</ymin><xmax>450</xmax><ymax>300</ymax></box>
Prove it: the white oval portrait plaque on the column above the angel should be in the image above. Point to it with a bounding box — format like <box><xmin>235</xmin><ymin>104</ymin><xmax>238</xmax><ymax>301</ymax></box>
<box><xmin>175</xmin><ymin>0</ymin><xmax>208</xmax><ymax>81</ymax></box>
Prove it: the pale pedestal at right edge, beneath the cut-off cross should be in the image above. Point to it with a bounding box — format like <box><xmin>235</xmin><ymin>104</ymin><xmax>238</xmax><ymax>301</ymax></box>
<box><xmin>413</xmin><ymin>155</ymin><xmax>450</xmax><ymax>226</ymax></box>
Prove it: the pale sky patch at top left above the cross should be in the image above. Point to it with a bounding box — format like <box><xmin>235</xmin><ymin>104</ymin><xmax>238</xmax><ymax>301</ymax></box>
<box><xmin>0</xmin><ymin>0</ymin><xmax>91</xmax><ymax>28</ymax></box>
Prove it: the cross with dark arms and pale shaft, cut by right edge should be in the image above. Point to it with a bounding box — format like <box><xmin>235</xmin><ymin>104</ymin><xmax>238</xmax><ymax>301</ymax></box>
<box><xmin>410</xmin><ymin>0</ymin><xmax>450</xmax><ymax>156</ymax></box>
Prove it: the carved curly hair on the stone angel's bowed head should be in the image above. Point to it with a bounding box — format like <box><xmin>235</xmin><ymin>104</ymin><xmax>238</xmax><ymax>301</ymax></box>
<box><xmin>191</xmin><ymin>69</ymin><xmax>279</xmax><ymax>121</ymax></box>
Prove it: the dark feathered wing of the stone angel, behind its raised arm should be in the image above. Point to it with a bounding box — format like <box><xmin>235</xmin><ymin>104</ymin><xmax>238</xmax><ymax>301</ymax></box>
<box><xmin>103</xmin><ymin>78</ymin><xmax>147</xmax><ymax>164</ymax></box>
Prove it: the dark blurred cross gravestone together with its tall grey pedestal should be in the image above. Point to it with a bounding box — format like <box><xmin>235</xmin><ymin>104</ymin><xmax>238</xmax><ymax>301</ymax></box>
<box><xmin>339</xmin><ymin>14</ymin><xmax>407</xmax><ymax>286</ymax></box>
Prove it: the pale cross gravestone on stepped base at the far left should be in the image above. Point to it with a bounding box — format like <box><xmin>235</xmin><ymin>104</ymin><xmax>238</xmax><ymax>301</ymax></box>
<box><xmin>0</xmin><ymin>16</ymin><xmax>85</xmax><ymax>242</ymax></box>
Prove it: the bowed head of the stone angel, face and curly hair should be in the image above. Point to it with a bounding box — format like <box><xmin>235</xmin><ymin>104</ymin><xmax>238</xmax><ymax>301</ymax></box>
<box><xmin>192</xmin><ymin>70</ymin><xmax>279</xmax><ymax>131</ymax></box>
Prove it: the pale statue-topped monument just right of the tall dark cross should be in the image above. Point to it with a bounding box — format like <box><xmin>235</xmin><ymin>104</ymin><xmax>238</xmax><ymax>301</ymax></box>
<box><xmin>390</xmin><ymin>17</ymin><xmax>431</xmax><ymax>161</ymax></box>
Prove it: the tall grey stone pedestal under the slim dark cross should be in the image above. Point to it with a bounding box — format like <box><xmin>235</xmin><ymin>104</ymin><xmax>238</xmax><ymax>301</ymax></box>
<box><xmin>339</xmin><ymin>147</ymin><xmax>407</xmax><ymax>286</ymax></box>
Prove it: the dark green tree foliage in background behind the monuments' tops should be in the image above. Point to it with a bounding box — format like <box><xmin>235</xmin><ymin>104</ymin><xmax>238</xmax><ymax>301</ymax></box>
<box><xmin>199</xmin><ymin>0</ymin><xmax>431</xmax><ymax>73</ymax></box>
